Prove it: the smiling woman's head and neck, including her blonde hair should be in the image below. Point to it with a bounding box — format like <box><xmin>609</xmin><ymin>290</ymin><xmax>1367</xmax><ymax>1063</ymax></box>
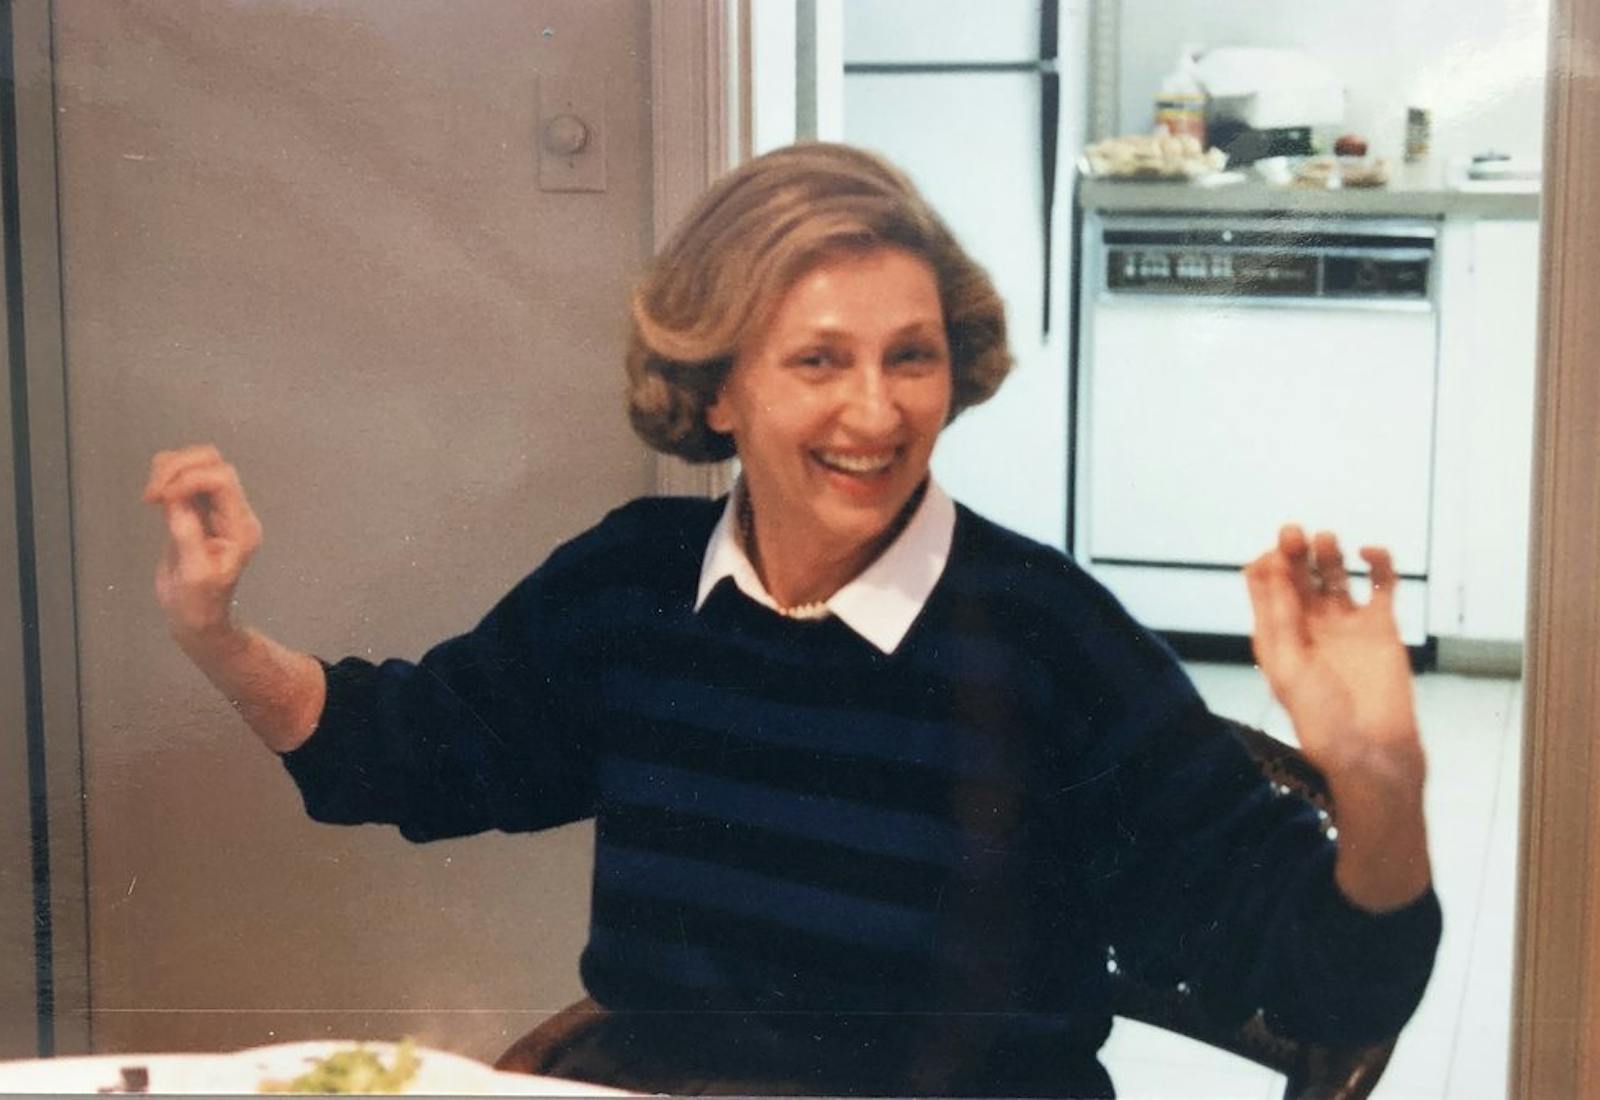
<box><xmin>629</xmin><ymin>145</ymin><xmax>1011</xmax><ymax>606</ymax></box>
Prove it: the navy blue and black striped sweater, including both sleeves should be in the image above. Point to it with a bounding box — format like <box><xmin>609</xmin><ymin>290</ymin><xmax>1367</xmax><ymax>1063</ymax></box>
<box><xmin>285</xmin><ymin>499</ymin><xmax>1438</xmax><ymax>1068</ymax></box>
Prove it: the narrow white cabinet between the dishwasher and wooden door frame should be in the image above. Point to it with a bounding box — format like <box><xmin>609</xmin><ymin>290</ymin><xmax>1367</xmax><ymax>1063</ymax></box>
<box><xmin>1429</xmin><ymin>219</ymin><xmax>1539</xmax><ymax>643</ymax></box>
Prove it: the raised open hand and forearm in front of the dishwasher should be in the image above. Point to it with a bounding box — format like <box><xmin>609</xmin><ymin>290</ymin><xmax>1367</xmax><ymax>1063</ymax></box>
<box><xmin>1245</xmin><ymin>526</ymin><xmax>1429</xmax><ymax>910</ymax></box>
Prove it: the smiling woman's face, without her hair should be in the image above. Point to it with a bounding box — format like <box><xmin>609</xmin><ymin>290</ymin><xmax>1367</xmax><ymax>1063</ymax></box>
<box><xmin>706</xmin><ymin>248</ymin><xmax>950</xmax><ymax>566</ymax></box>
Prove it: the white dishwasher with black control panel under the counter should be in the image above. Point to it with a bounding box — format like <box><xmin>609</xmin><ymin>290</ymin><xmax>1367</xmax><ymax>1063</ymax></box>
<box><xmin>1072</xmin><ymin>213</ymin><xmax>1438</xmax><ymax>646</ymax></box>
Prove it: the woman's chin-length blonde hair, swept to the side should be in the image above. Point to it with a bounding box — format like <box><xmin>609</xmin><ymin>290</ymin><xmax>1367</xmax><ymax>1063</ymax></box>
<box><xmin>627</xmin><ymin>142</ymin><xmax>1011</xmax><ymax>462</ymax></box>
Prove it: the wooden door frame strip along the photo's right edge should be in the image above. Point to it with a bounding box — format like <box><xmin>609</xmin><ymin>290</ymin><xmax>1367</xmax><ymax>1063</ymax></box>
<box><xmin>1509</xmin><ymin>0</ymin><xmax>1600</xmax><ymax>1100</ymax></box>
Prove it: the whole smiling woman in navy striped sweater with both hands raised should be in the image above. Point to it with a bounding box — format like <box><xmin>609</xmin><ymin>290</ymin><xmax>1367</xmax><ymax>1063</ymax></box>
<box><xmin>131</xmin><ymin>145</ymin><xmax>1440</xmax><ymax>1095</ymax></box>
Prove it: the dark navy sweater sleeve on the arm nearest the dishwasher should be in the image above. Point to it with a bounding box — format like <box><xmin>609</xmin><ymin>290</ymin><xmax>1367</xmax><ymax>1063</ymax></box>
<box><xmin>1080</xmin><ymin>578</ymin><xmax>1442</xmax><ymax>1042</ymax></box>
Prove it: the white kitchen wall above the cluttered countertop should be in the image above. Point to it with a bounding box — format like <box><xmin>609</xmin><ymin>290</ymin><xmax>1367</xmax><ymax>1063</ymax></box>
<box><xmin>1118</xmin><ymin>0</ymin><xmax>1549</xmax><ymax>158</ymax></box>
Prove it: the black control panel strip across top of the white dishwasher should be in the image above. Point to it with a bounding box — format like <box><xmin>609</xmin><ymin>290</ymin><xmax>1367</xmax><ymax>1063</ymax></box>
<box><xmin>1101</xmin><ymin>217</ymin><xmax>1438</xmax><ymax>302</ymax></box>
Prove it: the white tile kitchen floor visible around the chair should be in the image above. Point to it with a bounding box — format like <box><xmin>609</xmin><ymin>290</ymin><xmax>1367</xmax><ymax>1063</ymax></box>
<box><xmin>1102</xmin><ymin>664</ymin><xmax>1522</xmax><ymax>1100</ymax></box>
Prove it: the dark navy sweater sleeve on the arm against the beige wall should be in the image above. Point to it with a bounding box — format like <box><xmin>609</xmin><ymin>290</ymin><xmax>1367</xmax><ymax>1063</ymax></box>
<box><xmin>283</xmin><ymin>566</ymin><xmax>594</xmax><ymax>841</ymax></box>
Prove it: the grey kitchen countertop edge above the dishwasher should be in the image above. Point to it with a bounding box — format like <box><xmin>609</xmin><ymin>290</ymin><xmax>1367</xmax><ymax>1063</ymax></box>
<box><xmin>1078</xmin><ymin>165</ymin><xmax>1539</xmax><ymax>219</ymax></box>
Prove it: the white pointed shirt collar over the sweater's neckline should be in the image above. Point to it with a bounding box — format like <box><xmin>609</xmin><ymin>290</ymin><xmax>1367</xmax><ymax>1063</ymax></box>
<box><xmin>694</xmin><ymin>481</ymin><xmax>955</xmax><ymax>654</ymax></box>
